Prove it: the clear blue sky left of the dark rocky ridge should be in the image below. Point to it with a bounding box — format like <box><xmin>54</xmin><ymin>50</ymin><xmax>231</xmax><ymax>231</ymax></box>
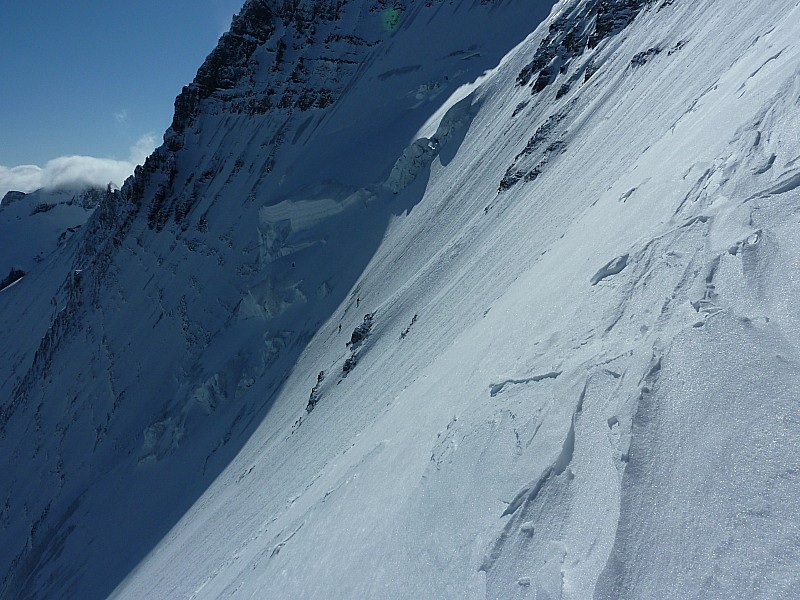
<box><xmin>0</xmin><ymin>0</ymin><xmax>244</xmax><ymax>198</ymax></box>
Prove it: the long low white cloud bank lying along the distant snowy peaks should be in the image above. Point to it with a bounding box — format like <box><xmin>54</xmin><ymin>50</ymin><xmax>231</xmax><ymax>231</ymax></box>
<box><xmin>0</xmin><ymin>133</ymin><xmax>157</xmax><ymax>200</ymax></box>
